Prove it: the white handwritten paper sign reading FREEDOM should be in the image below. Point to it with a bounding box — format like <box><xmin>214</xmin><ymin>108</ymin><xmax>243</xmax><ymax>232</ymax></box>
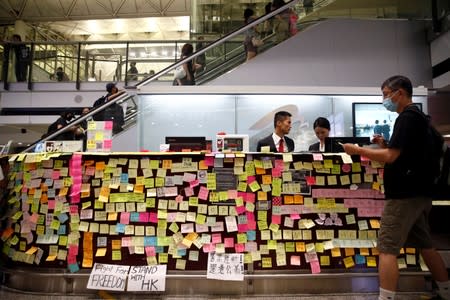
<box><xmin>87</xmin><ymin>263</ymin><xmax>130</xmax><ymax>291</ymax></box>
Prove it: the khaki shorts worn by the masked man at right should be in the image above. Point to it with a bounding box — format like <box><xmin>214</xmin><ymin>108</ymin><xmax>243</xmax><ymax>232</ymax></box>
<box><xmin>378</xmin><ymin>197</ymin><xmax>433</xmax><ymax>255</ymax></box>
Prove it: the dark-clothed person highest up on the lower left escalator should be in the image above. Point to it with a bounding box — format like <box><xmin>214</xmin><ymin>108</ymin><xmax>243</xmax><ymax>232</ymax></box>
<box><xmin>92</xmin><ymin>82</ymin><xmax>125</xmax><ymax>134</ymax></box>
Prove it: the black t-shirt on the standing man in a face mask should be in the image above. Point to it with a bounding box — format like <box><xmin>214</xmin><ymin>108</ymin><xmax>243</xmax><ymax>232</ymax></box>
<box><xmin>384</xmin><ymin>105</ymin><xmax>433</xmax><ymax>198</ymax></box>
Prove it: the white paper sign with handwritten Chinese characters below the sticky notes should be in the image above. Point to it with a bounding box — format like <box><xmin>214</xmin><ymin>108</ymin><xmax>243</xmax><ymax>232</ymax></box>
<box><xmin>206</xmin><ymin>252</ymin><xmax>244</xmax><ymax>281</ymax></box>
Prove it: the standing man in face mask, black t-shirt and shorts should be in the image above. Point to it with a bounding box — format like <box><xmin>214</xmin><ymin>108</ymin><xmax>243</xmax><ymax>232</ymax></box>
<box><xmin>343</xmin><ymin>76</ymin><xmax>450</xmax><ymax>300</ymax></box>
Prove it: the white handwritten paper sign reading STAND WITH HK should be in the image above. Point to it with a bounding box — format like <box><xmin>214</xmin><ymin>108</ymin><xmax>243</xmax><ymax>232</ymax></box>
<box><xmin>127</xmin><ymin>265</ymin><xmax>167</xmax><ymax>292</ymax></box>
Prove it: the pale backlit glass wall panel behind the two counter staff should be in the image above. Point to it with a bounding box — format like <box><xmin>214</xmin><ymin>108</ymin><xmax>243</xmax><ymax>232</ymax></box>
<box><xmin>138</xmin><ymin>94</ymin><xmax>427</xmax><ymax>152</ymax></box>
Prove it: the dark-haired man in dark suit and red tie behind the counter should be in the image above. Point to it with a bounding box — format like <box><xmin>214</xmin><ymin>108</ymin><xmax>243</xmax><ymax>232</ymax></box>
<box><xmin>256</xmin><ymin>111</ymin><xmax>295</xmax><ymax>152</ymax></box>
